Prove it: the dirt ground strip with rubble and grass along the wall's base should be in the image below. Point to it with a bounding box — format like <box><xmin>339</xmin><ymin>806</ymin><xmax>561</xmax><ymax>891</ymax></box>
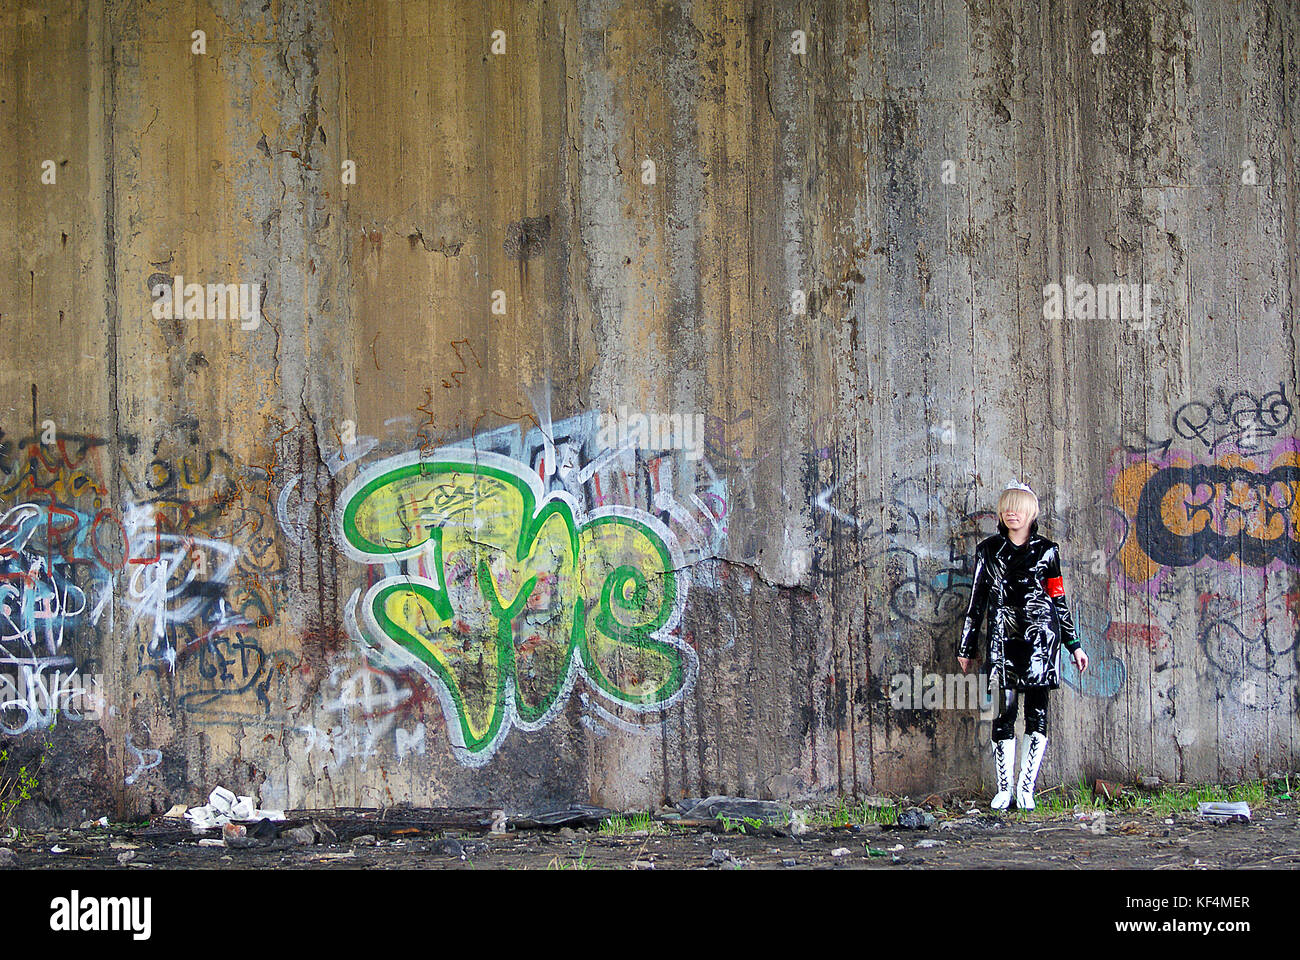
<box><xmin>0</xmin><ymin>799</ymin><xmax>1300</xmax><ymax>870</ymax></box>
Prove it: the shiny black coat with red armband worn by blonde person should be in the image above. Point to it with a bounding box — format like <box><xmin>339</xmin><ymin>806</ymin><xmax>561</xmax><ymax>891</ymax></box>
<box><xmin>957</xmin><ymin>522</ymin><xmax>1079</xmax><ymax>689</ymax></box>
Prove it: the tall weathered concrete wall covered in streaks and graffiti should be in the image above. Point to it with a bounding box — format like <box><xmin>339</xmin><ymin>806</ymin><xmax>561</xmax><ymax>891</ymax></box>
<box><xmin>0</xmin><ymin>0</ymin><xmax>1300</xmax><ymax>820</ymax></box>
